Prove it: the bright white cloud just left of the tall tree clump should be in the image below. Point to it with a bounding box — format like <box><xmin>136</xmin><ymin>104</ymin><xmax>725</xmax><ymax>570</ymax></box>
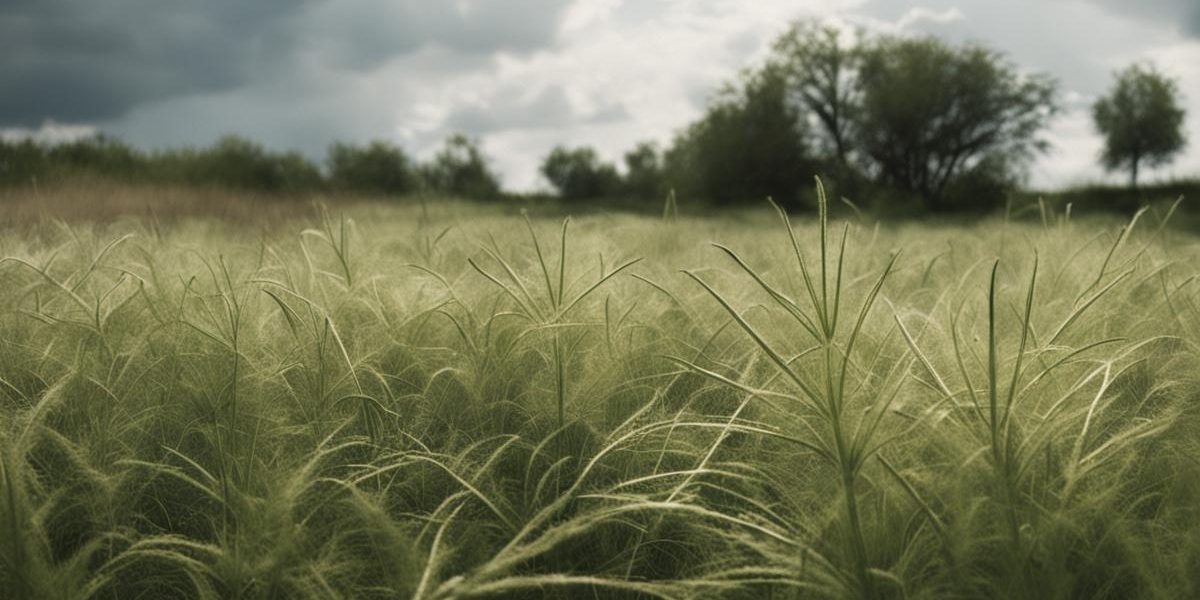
<box><xmin>418</xmin><ymin>0</ymin><xmax>860</xmax><ymax>190</ymax></box>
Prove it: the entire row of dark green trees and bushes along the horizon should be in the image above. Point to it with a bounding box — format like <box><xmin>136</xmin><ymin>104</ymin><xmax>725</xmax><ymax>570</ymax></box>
<box><xmin>0</xmin><ymin>20</ymin><xmax>1187</xmax><ymax>211</ymax></box>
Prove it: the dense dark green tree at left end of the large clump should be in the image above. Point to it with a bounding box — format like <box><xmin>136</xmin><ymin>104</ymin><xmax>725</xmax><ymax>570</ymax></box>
<box><xmin>666</xmin><ymin>66</ymin><xmax>820</xmax><ymax>206</ymax></box>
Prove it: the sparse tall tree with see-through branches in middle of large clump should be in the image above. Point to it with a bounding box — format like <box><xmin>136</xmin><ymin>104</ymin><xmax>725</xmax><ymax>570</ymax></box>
<box><xmin>773</xmin><ymin>20</ymin><xmax>860</xmax><ymax>169</ymax></box>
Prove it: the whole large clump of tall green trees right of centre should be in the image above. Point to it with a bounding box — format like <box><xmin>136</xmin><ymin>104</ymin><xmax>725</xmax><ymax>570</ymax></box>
<box><xmin>648</xmin><ymin>20</ymin><xmax>1057</xmax><ymax>210</ymax></box>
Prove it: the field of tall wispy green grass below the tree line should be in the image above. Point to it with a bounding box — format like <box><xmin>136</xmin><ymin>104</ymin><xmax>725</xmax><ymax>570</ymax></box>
<box><xmin>0</xmin><ymin>184</ymin><xmax>1200</xmax><ymax>599</ymax></box>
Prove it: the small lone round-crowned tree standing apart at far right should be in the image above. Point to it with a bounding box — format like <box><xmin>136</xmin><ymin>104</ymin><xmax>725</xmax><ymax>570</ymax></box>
<box><xmin>1092</xmin><ymin>65</ymin><xmax>1187</xmax><ymax>188</ymax></box>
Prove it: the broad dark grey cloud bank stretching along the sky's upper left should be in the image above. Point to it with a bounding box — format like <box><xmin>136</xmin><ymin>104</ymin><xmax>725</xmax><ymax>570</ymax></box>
<box><xmin>0</xmin><ymin>0</ymin><xmax>565</xmax><ymax>126</ymax></box>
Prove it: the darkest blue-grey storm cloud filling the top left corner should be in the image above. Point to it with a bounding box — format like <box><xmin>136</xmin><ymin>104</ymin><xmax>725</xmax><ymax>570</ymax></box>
<box><xmin>0</xmin><ymin>0</ymin><xmax>302</xmax><ymax>125</ymax></box>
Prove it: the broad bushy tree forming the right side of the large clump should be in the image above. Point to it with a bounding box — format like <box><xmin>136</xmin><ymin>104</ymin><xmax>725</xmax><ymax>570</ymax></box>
<box><xmin>856</xmin><ymin>37</ymin><xmax>1057</xmax><ymax>210</ymax></box>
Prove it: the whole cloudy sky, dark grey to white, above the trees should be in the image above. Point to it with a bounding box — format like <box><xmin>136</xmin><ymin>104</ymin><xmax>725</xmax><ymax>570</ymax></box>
<box><xmin>0</xmin><ymin>0</ymin><xmax>1200</xmax><ymax>191</ymax></box>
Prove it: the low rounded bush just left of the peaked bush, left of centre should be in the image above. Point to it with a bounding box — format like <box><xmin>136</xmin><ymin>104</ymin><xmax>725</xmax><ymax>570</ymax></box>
<box><xmin>328</xmin><ymin>140</ymin><xmax>418</xmax><ymax>196</ymax></box>
